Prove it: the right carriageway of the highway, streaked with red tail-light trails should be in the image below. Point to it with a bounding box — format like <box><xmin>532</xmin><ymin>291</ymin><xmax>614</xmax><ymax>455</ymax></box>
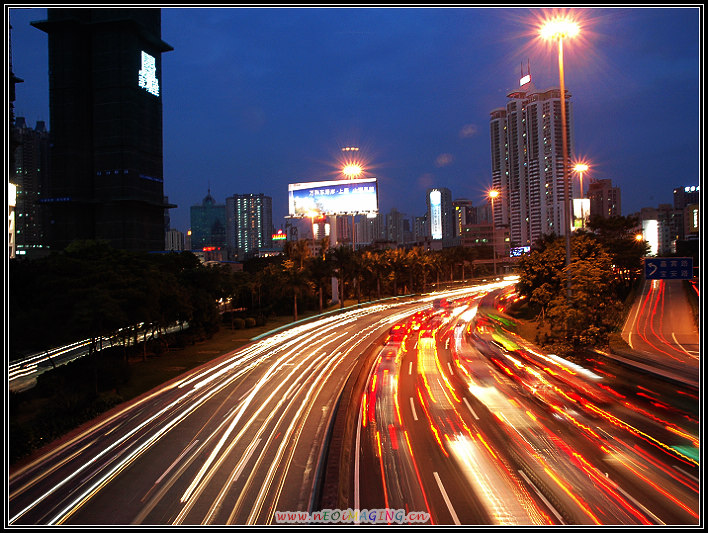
<box><xmin>346</xmin><ymin>286</ymin><xmax>699</xmax><ymax>525</ymax></box>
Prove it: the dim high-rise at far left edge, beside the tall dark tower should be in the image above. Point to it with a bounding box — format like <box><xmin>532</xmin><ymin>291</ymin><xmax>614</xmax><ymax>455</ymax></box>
<box><xmin>10</xmin><ymin>117</ymin><xmax>49</xmax><ymax>258</ymax></box>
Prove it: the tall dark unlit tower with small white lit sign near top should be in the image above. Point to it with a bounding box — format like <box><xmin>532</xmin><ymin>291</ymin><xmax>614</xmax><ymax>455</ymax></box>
<box><xmin>32</xmin><ymin>8</ymin><xmax>174</xmax><ymax>251</ymax></box>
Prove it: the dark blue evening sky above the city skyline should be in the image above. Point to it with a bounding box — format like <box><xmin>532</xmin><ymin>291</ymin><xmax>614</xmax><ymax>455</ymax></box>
<box><xmin>10</xmin><ymin>5</ymin><xmax>703</xmax><ymax>235</ymax></box>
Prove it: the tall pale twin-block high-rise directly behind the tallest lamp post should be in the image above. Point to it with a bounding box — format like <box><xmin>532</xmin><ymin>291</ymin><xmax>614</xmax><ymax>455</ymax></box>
<box><xmin>490</xmin><ymin>71</ymin><xmax>575</xmax><ymax>246</ymax></box>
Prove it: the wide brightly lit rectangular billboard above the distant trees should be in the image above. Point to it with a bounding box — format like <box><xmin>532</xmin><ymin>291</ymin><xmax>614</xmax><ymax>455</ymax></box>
<box><xmin>288</xmin><ymin>178</ymin><xmax>379</xmax><ymax>218</ymax></box>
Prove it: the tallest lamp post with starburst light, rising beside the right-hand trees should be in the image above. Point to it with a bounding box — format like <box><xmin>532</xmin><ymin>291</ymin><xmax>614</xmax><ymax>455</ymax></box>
<box><xmin>540</xmin><ymin>19</ymin><xmax>580</xmax><ymax>300</ymax></box>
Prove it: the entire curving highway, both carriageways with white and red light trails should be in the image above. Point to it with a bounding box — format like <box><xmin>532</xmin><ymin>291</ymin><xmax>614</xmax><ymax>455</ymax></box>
<box><xmin>8</xmin><ymin>281</ymin><xmax>699</xmax><ymax>526</ymax></box>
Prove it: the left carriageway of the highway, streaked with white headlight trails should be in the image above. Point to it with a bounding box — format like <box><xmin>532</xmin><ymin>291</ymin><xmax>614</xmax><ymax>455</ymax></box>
<box><xmin>8</xmin><ymin>282</ymin><xmax>509</xmax><ymax>525</ymax></box>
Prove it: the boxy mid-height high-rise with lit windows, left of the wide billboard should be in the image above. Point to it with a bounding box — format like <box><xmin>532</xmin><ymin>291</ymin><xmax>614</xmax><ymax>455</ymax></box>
<box><xmin>226</xmin><ymin>194</ymin><xmax>273</xmax><ymax>259</ymax></box>
